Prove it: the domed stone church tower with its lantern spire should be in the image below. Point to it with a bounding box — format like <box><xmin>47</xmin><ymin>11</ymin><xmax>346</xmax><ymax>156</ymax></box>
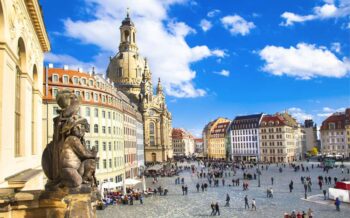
<box><xmin>107</xmin><ymin>12</ymin><xmax>146</xmax><ymax>102</ymax></box>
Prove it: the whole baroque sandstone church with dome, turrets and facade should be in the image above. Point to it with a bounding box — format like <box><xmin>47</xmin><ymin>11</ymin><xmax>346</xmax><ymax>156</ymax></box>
<box><xmin>107</xmin><ymin>14</ymin><xmax>173</xmax><ymax>163</ymax></box>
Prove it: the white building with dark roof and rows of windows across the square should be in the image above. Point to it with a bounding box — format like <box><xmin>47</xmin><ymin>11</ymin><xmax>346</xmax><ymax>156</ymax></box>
<box><xmin>228</xmin><ymin>114</ymin><xmax>263</xmax><ymax>161</ymax></box>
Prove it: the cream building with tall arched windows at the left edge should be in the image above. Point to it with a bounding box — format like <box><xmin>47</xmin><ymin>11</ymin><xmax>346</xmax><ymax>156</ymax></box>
<box><xmin>0</xmin><ymin>0</ymin><xmax>50</xmax><ymax>189</ymax></box>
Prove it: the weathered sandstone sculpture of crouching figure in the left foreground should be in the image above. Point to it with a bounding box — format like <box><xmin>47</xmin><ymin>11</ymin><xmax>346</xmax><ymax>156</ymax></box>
<box><xmin>42</xmin><ymin>90</ymin><xmax>97</xmax><ymax>189</ymax></box>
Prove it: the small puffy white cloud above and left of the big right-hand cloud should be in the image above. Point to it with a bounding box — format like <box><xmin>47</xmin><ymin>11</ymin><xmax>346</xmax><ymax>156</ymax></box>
<box><xmin>221</xmin><ymin>15</ymin><xmax>255</xmax><ymax>36</ymax></box>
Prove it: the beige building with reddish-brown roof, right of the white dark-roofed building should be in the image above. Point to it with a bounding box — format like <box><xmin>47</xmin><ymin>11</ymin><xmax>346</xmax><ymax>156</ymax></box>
<box><xmin>259</xmin><ymin>113</ymin><xmax>304</xmax><ymax>163</ymax></box>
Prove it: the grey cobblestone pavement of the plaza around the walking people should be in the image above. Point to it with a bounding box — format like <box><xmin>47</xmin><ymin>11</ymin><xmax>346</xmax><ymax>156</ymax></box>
<box><xmin>97</xmin><ymin>162</ymin><xmax>350</xmax><ymax>217</ymax></box>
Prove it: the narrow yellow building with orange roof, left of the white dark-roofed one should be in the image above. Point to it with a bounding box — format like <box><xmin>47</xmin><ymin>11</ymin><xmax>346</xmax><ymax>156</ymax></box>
<box><xmin>203</xmin><ymin>118</ymin><xmax>231</xmax><ymax>159</ymax></box>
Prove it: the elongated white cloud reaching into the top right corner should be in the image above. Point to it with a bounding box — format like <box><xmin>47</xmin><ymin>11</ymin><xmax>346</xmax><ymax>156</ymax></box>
<box><xmin>281</xmin><ymin>0</ymin><xmax>350</xmax><ymax>26</ymax></box>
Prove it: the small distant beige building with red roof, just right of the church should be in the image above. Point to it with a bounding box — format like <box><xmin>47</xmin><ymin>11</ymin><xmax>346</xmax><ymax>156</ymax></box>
<box><xmin>172</xmin><ymin>128</ymin><xmax>195</xmax><ymax>157</ymax></box>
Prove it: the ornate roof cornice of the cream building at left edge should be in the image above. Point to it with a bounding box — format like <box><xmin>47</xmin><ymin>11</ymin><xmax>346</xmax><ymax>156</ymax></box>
<box><xmin>25</xmin><ymin>0</ymin><xmax>51</xmax><ymax>52</ymax></box>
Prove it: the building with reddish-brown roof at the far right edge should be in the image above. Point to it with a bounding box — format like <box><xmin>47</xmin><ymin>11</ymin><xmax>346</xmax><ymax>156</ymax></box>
<box><xmin>320</xmin><ymin>108</ymin><xmax>350</xmax><ymax>157</ymax></box>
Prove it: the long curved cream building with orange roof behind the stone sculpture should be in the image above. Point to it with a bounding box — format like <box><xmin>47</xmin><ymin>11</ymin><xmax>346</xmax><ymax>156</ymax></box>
<box><xmin>42</xmin><ymin>65</ymin><xmax>128</xmax><ymax>183</ymax></box>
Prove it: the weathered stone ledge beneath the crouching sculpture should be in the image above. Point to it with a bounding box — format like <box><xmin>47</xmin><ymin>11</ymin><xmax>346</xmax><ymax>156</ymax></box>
<box><xmin>0</xmin><ymin>186</ymin><xmax>98</xmax><ymax>218</ymax></box>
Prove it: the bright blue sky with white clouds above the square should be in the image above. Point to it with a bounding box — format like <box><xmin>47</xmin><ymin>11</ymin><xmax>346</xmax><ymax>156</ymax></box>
<box><xmin>40</xmin><ymin>0</ymin><xmax>350</xmax><ymax>135</ymax></box>
